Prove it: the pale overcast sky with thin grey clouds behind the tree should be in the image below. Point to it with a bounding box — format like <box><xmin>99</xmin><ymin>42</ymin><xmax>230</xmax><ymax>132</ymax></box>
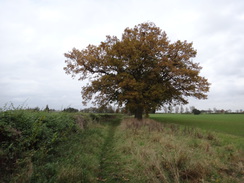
<box><xmin>0</xmin><ymin>0</ymin><xmax>244</xmax><ymax>111</ymax></box>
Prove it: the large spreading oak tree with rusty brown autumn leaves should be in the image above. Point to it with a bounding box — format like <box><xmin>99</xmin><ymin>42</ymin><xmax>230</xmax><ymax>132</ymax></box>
<box><xmin>64</xmin><ymin>22</ymin><xmax>210</xmax><ymax>119</ymax></box>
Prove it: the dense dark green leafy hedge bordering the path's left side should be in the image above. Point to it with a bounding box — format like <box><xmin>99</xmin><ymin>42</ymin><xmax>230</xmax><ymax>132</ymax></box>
<box><xmin>0</xmin><ymin>110</ymin><xmax>78</xmax><ymax>182</ymax></box>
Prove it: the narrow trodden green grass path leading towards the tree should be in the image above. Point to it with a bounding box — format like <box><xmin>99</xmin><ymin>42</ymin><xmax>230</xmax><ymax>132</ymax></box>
<box><xmin>97</xmin><ymin>119</ymin><xmax>123</xmax><ymax>182</ymax></box>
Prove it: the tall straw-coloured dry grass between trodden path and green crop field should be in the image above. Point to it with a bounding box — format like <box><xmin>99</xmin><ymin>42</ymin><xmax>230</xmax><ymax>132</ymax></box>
<box><xmin>117</xmin><ymin>118</ymin><xmax>244</xmax><ymax>183</ymax></box>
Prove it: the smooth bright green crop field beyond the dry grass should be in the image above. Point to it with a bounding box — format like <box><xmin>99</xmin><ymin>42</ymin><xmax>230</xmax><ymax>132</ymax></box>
<box><xmin>150</xmin><ymin>114</ymin><xmax>244</xmax><ymax>137</ymax></box>
